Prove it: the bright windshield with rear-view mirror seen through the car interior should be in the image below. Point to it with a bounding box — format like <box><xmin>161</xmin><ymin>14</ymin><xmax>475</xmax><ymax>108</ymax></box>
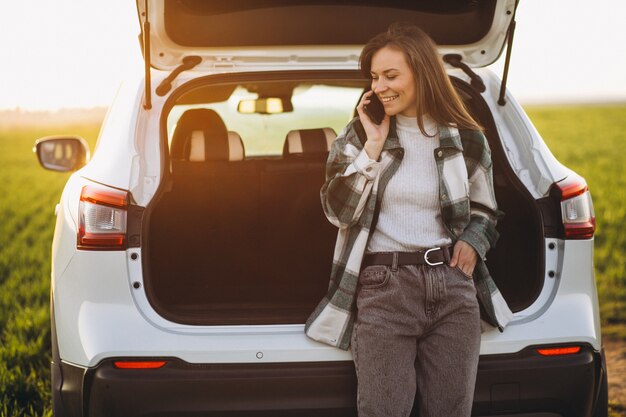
<box><xmin>167</xmin><ymin>80</ymin><xmax>368</xmax><ymax>158</ymax></box>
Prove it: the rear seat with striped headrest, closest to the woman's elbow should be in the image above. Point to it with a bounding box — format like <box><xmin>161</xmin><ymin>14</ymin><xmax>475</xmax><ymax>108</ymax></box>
<box><xmin>261</xmin><ymin>128</ymin><xmax>337</xmax><ymax>300</ymax></box>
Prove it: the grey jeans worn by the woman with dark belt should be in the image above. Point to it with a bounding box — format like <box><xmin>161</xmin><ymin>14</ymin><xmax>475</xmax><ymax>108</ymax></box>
<box><xmin>351</xmin><ymin>265</ymin><xmax>481</xmax><ymax>417</ymax></box>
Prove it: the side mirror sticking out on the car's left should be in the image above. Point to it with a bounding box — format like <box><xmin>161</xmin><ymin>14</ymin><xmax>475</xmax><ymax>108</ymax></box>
<box><xmin>33</xmin><ymin>136</ymin><xmax>89</xmax><ymax>172</ymax></box>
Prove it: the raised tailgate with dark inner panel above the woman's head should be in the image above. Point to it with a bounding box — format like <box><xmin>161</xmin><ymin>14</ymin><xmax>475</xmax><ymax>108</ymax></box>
<box><xmin>137</xmin><ymin>0</ymin><xmax>516</xmax><ymax>70</ymax></box>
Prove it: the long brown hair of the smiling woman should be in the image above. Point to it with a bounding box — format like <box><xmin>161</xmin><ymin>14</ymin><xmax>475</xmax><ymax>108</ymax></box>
<box><xmin>359</xmin><ymin>23</ymin><xmax>483</xmax><ymax>134</ymax></box>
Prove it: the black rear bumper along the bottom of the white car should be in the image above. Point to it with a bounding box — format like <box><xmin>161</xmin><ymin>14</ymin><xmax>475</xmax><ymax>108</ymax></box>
<box><xmin>52</xmin><ymin>346</ymin><xmax>605</xmax><ymax>417</ymax></box>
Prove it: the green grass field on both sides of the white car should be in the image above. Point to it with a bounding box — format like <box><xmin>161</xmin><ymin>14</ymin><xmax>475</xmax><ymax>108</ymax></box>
<box><xmin>0</xmin><ymin>106</ymin><xmax>626</xmax><ymax>417</ymax></box>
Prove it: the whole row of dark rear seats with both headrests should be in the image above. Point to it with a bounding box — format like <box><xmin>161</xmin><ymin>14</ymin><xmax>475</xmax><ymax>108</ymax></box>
<box><xmin>149</xmin><ymin>115</ymin><xmax>337</xmax><ymax>310</ymax></box>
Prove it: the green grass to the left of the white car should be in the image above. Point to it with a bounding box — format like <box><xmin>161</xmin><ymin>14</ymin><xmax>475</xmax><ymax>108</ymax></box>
<box><xmin>0</xmin><ymin>126</ymin><xmax>99</xmax><ymax>417</ymax></box>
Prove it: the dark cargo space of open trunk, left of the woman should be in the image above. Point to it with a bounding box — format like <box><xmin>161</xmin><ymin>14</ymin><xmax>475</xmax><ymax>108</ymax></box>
<box><xmin>148</xmin><ymin>150</ymin><xmax>336</xmax><ymax>324</ymax></box>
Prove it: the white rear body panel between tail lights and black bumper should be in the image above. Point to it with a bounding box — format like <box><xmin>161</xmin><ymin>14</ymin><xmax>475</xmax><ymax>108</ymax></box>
<box><xmin>53</xmin><ymin>211</ymin><xmax>600</xmax><ymax>367</ymax></box>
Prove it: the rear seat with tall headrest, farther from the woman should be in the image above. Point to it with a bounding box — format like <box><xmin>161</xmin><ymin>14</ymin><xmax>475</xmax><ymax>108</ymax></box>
<box><xmin>151</xmin><ymin>109</ymin><xmax>260</xmax><ymax>307</ymax></box>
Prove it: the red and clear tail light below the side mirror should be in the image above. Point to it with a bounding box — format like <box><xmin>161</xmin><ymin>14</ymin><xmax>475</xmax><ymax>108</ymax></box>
<box><xmin>78</xmin><ymin>185</ymin><xmax>129</xmax><ymax>250</ymax></box>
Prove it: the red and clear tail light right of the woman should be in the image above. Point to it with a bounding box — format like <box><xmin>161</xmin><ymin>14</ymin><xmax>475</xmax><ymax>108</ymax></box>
<box><xmin>556</xmin><ymin>175</ymin><xmax>596</xmax><ymax>239</ymax></box>
